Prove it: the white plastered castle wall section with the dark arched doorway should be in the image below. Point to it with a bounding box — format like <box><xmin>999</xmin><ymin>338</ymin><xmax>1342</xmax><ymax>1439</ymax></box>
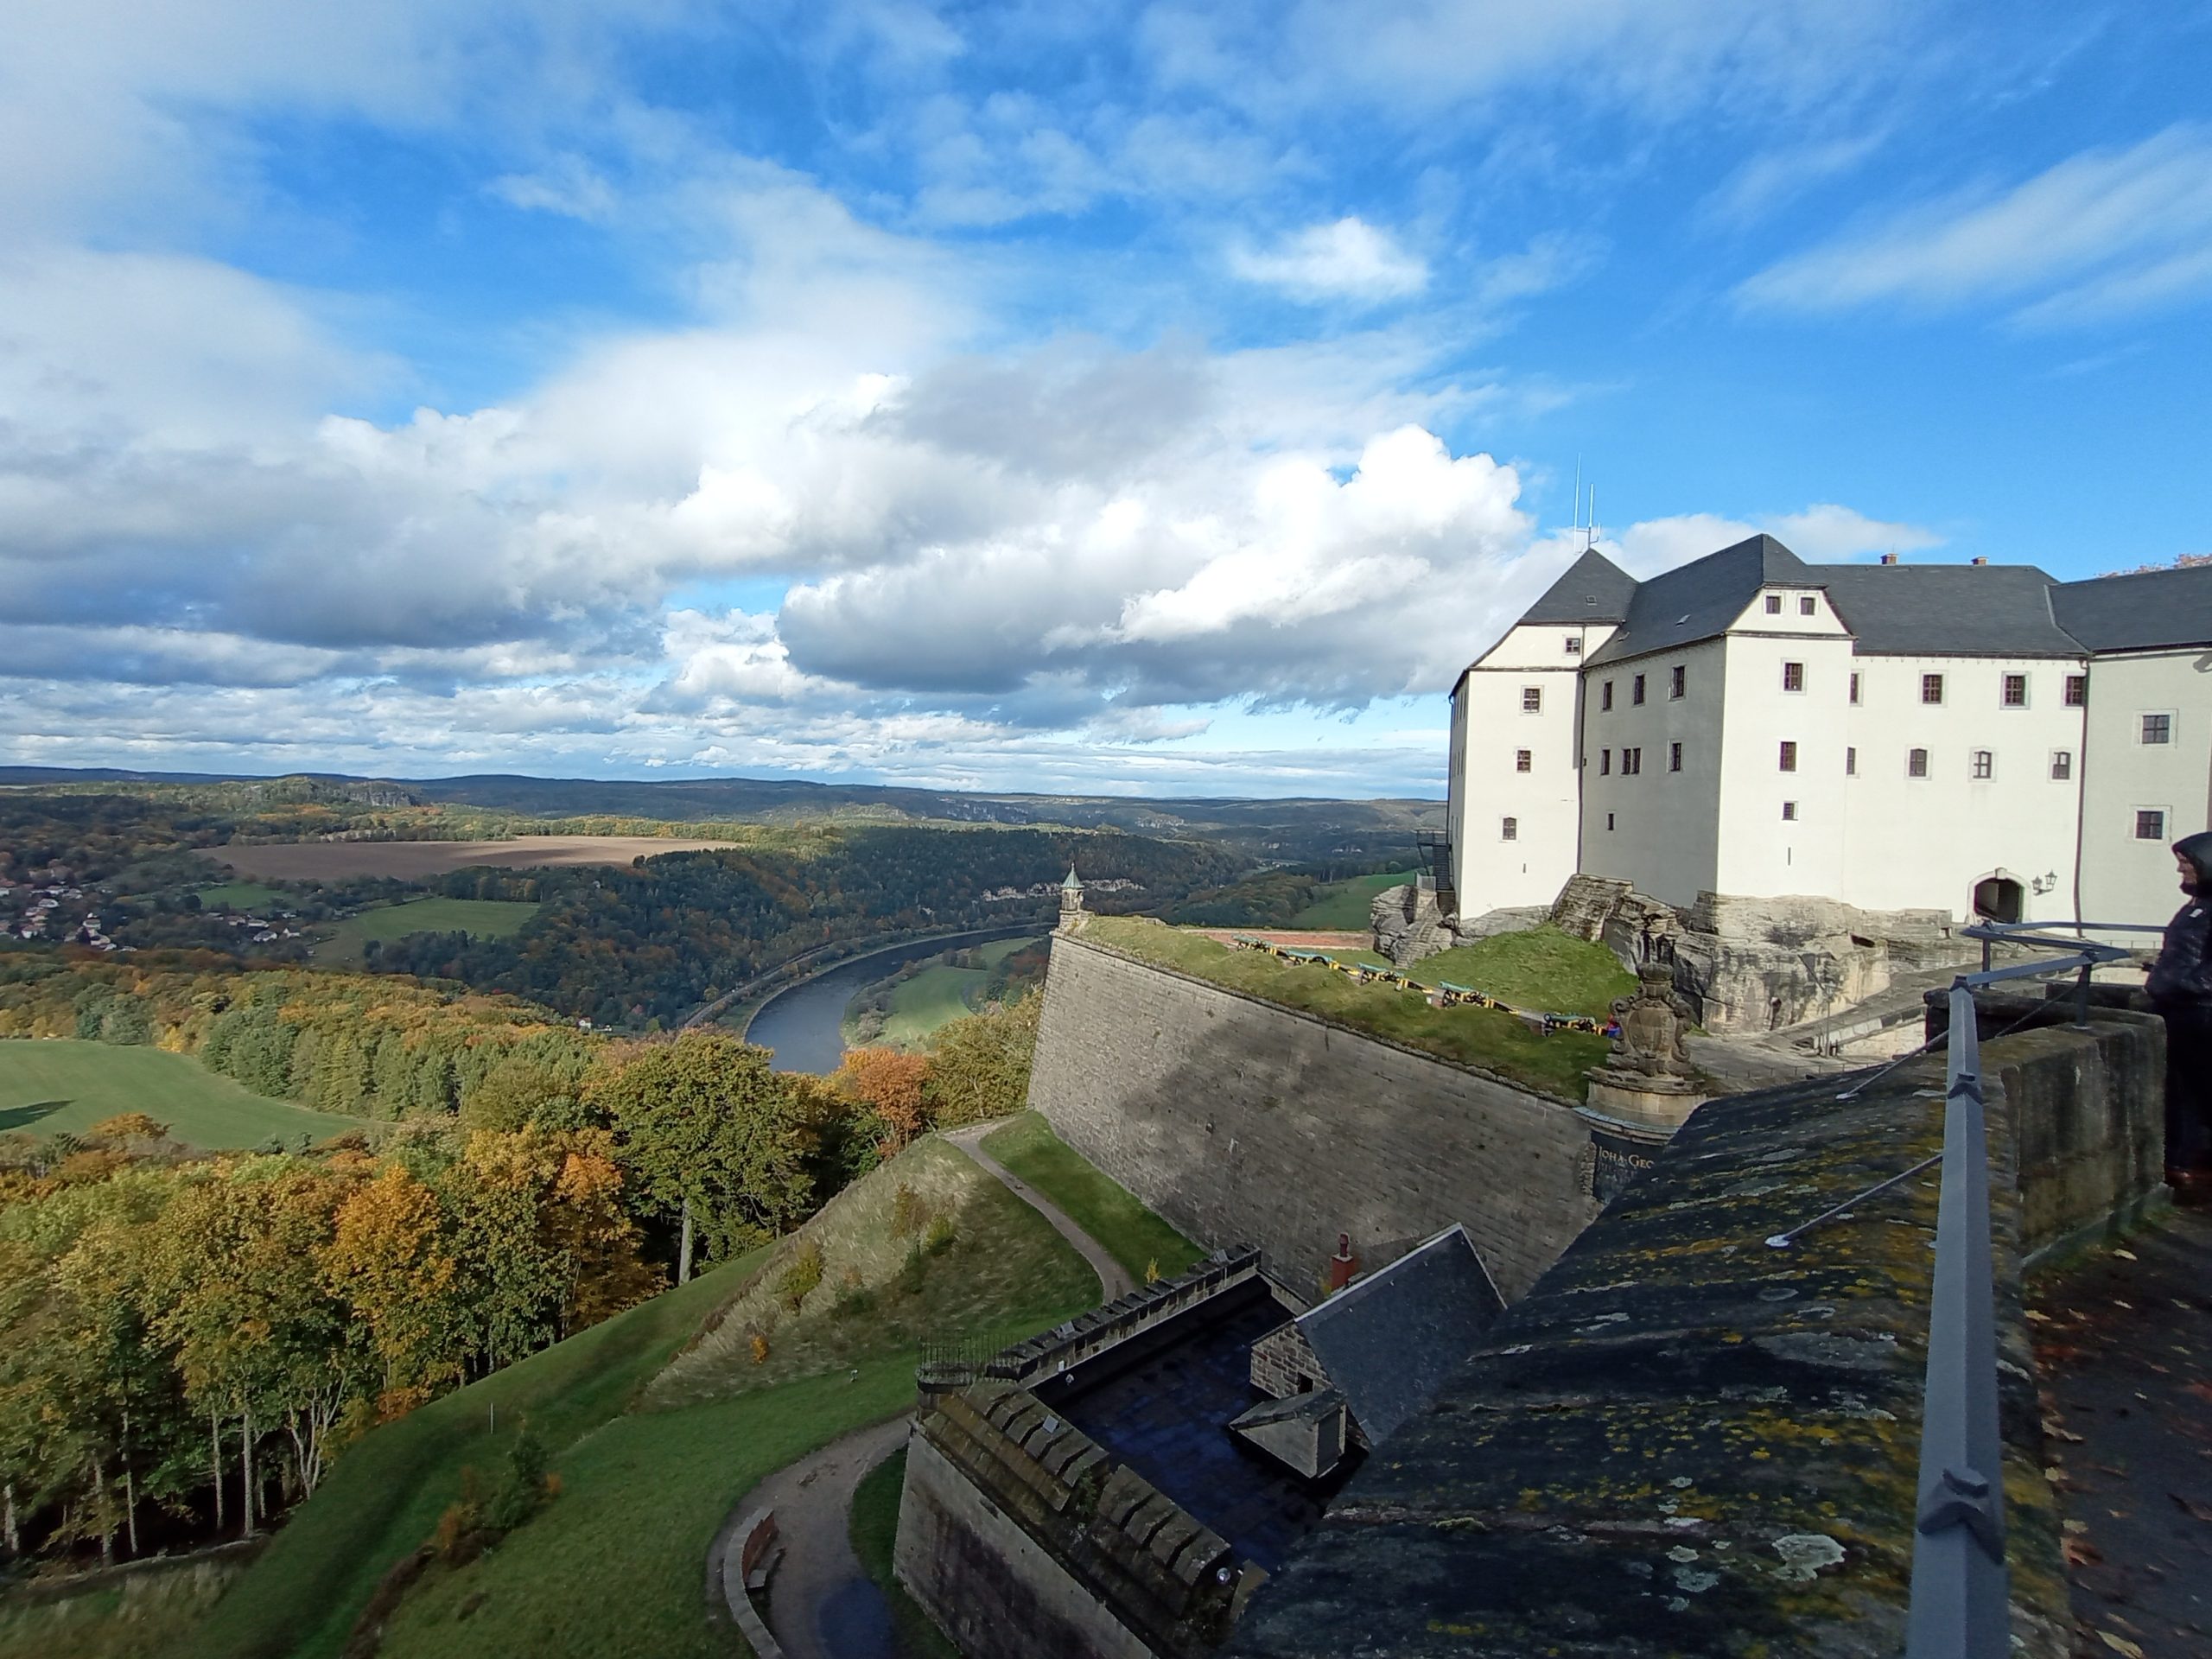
<box><xmin>1838</xmin><ymin>655</ymin><xmax>2084</xmax><ymax>920</ymax></box>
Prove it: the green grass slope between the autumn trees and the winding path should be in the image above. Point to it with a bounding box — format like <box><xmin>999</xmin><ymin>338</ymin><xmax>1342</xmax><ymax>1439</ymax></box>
<box><xmin>188</xmin><ymin>1139</ymin><xmax>1097</xmax><ymax>1659</ymax></box>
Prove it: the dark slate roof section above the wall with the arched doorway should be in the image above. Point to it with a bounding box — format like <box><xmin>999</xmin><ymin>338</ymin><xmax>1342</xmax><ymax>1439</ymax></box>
<box><xmin>1814</xmin><ymin>564</ymin><xmax>2082</xmax><ymax>657</ymax></box>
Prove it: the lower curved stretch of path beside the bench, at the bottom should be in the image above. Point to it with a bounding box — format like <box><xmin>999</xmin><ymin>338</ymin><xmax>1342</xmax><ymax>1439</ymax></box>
<box><xmin>721</xmin><ymin>1418</ymin><xmax>909</xmax><ymax>1659</ymax></box>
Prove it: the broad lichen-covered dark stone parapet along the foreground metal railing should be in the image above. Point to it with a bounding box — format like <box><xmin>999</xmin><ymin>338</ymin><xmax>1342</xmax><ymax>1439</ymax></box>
<box><xmin>1230</xmin><ymin>1000</ymin><xmax>2164</xmax><ymax>1659</ymax></box>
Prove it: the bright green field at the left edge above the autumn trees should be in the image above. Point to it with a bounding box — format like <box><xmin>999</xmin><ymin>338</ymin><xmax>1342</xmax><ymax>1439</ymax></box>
<box><xmin>0</xmin><ymin>1038</ymin><xmax>372</xmax><ymax>1153</ymax></box>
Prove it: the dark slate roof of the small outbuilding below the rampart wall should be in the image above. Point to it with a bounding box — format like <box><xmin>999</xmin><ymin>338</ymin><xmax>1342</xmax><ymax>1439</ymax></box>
<box><xmin>1299</xmin><ymin>1228</ymin><xmax>1504</xmax><ymax>1446</ymax></box>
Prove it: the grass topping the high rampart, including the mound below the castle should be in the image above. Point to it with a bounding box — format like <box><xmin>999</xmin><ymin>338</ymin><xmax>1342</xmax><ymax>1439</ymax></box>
<box><xmin>1082</xmin><ymin>916</ymin><xmax>1635</xmax><ymax>1102</ymax></box>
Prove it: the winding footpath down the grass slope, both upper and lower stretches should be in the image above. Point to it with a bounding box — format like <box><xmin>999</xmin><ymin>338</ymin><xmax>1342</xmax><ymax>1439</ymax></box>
<box><xmin>715</xmin><ymin>1122</ymin><xmax>1137</xmax><ymax>1659</ymax></box>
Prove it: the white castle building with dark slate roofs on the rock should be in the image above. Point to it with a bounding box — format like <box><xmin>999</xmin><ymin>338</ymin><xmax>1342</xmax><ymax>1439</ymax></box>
<box><xmin>1446</xmin><ymin>536</ymin><xmax>2212</xmax><ymax>942</ymax></box>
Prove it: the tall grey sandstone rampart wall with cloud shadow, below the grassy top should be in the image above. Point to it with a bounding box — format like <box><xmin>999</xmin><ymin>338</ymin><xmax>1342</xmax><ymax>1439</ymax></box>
<box><xmin>1028</xmin><ymin>936</ymin><xmax>1599</xmax><ymax>1300</ymax></box>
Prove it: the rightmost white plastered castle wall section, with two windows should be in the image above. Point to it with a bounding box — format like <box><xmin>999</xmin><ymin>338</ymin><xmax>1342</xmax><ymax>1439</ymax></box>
<box><xmin>2082</xmin><ymin>648</ymin><xmax>2212</xmax><ymax>923</ymax></box>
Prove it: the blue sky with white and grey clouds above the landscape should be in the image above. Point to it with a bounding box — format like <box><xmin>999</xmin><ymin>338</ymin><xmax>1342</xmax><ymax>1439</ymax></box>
<box><xmin>0</xmin><ymin>0</ymin><xmax>2212</xmax><ymax>794</ymax></box>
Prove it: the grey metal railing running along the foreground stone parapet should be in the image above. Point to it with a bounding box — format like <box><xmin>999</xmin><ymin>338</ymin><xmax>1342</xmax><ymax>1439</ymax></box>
<box><xmin>1902</xmin><ymin>923</ymin><xmax>2159</xmax><ymax>1659</ymax></box>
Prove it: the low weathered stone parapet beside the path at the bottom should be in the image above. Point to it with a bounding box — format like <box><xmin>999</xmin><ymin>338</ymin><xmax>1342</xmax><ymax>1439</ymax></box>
<box><xmin>896</xmin><ymin>1382</ymin><xmax>1265</xmax><ymax>1659</ymax></box>
